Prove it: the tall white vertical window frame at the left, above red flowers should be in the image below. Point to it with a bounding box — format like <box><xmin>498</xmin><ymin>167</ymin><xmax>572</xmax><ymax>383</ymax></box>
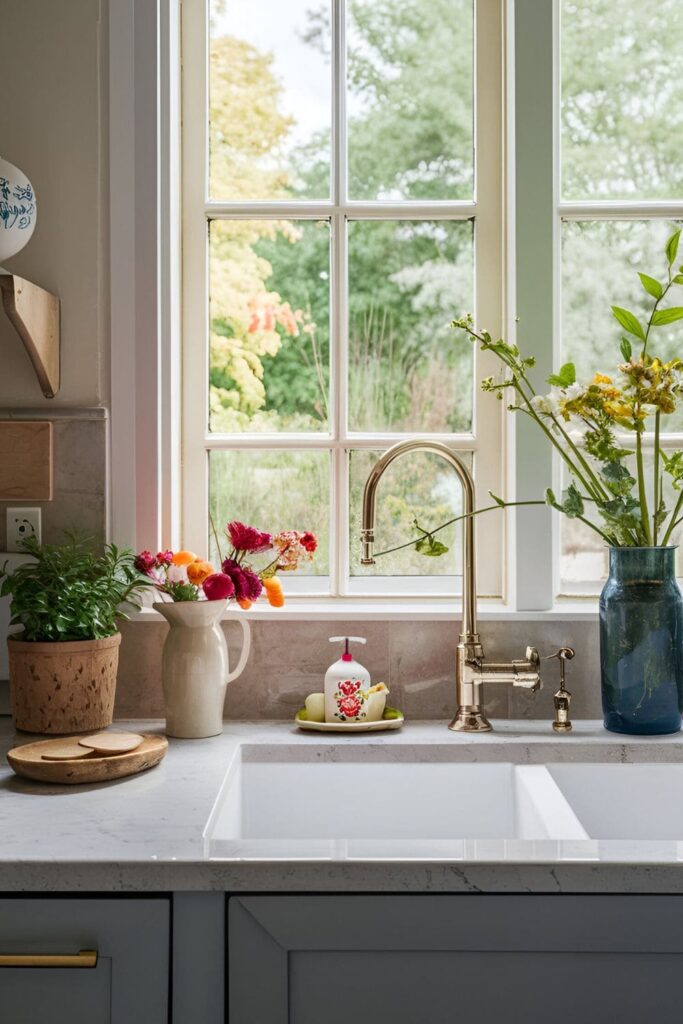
<box><xmin>109</xmin><ymin>0</ymin><xmax>180</xmax><ymax>550</ymax></box>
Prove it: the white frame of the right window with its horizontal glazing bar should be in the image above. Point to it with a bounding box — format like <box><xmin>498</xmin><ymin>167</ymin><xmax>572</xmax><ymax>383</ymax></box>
<box><xmin>507</xmin><ymin>0</ymin><xmax>683</xmax><ymax>616</ymax></box>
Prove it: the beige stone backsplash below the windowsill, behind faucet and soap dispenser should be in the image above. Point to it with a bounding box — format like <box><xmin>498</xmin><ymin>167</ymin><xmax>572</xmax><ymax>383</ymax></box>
<box><xmin>116</xmin><ymin>620</ymin><xmax>601</xmax><ymax>721</ymax></box>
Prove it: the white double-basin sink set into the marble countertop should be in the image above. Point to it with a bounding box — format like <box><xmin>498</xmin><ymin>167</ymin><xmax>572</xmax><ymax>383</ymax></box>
<box><xmin>204</xmin><ymin>742</ymin><xmax>683</xmax><ymax>862</ymax></box>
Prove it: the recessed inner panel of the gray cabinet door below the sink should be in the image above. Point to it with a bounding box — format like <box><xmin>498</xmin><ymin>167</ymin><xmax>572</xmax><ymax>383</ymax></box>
<box><xmin>290</xmin><ymin>949</ymin><xmax>683</xmax><ymax>1024</ymax></box>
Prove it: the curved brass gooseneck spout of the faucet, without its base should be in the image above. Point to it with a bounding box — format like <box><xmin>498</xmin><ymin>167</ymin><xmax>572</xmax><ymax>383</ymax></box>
<box><xmin>360</xmin><ymin>440</ymin><xmax>478</xmax><ymax>642</ymax></box>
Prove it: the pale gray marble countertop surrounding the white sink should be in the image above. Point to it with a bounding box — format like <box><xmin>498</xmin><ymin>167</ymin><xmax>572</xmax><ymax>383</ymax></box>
<box><xmin>0</xmin><ymin>719</ymin><xmax>683</xmax><ymax>893</ymax></box>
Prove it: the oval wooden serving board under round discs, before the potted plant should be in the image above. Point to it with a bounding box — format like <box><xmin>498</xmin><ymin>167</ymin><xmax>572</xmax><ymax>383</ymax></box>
<box><xmin>7</xmin><ymin>735</ymin><xmax>168</xmax><ymax>785</ymax></box>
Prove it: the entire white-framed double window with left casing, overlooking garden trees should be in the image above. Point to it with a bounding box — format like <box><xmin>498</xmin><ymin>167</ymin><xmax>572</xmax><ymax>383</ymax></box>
<box><xmin>110</xmin><ymin>0</ymin><xmax>683</xmax><ymax>614</ymax></box>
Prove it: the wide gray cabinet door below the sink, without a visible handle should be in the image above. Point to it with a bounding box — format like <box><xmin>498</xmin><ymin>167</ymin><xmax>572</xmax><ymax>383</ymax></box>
<box><xmin>228</xmin><ymin>894</ymin><xmax>683</xmax><ymax>1024</ymax></box>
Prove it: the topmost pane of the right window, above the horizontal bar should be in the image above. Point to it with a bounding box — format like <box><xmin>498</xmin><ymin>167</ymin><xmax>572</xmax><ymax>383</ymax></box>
<box><xmin>560</xmin><ymin>0</ymin><xmax>683</xmax><ymax>200</ymax></box>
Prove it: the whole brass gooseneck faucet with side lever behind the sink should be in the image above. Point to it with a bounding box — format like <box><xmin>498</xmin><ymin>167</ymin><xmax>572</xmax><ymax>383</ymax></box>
<box><xmin>360</xmin><ymin>439</ymin><xmax>542</xmax><ymax>732</ymax></box>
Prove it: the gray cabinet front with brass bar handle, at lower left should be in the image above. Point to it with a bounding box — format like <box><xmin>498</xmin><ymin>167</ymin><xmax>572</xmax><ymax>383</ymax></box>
<box><xmin>0</xmin><ymin>896</ymin><xmax>170</xmax><ymax>1024</ymax></box>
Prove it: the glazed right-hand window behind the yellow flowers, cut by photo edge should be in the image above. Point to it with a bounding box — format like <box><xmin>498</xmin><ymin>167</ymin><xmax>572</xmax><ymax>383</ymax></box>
<box><xmin>556</xmin><ymin>0</ymin><xmax>683</xmax><ymax>594</ymax></box>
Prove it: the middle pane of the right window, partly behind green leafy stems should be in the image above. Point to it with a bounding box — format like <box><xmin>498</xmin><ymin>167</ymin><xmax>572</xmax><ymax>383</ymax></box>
<box><xmin>562</xmin><ymin>220</ymin><xmax>683</xmax><ymax>432</ymax></box>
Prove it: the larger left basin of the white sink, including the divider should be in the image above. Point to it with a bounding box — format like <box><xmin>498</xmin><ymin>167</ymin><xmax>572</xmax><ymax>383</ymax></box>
<box><xmin>204</xmin><ymin>743</ymin><xmax>588</xmax><ymax>860</ymax></box>
